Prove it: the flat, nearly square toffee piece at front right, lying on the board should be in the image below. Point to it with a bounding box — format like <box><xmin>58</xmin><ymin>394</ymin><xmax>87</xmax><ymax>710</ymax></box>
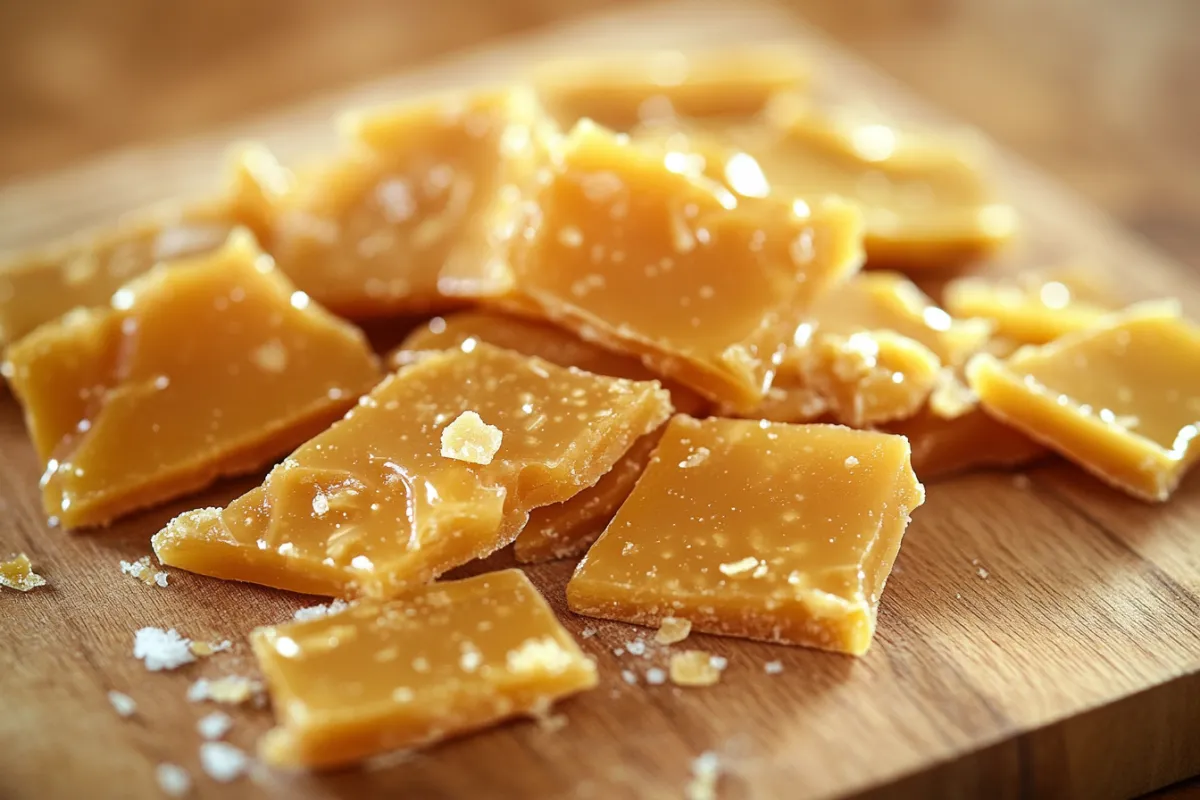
<box><xmin>566</xmin><ymin>415</ymin><xmax>924</xmax><ymax>655</ymax></box>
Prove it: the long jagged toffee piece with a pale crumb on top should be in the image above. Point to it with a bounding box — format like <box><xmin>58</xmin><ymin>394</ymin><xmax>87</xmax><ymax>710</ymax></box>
<box><xmin>154</xmin><ymin>341</ymin><xmax>671</xmax><ymax>597</ymax></box>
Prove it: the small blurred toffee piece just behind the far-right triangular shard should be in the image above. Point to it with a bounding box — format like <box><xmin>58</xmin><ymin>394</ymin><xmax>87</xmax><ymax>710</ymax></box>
<box><xmin>942</xmin><ymin>272</ymin><xmax>1116</xmax><ymax>344</ymax></box>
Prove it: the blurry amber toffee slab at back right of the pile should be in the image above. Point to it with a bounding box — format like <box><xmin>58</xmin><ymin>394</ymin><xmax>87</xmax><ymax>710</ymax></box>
<box><xmin>635</xmin><ymin>94</ymin><xmax>1016</xmax><ymax>273</ymax></box>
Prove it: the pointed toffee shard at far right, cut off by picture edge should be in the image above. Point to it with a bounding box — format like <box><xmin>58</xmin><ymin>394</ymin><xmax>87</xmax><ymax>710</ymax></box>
<box><xmin>967</xmin><ymin>302</ymin><xmax>1200</xmax><ymax>501</ymax></box>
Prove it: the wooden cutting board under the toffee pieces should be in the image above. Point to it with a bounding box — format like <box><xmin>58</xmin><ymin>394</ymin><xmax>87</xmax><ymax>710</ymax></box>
<box><xmin>0</xmin><ymin>0</ymin><xmax>1200</xmax><ymax>799</ymax></box>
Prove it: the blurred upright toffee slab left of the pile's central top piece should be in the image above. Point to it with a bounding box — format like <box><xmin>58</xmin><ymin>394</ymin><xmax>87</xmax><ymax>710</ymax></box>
<box><xmin>255</xmin><ymin>89</ymin><xmax>548</xmax><ymax>318</ymax></box>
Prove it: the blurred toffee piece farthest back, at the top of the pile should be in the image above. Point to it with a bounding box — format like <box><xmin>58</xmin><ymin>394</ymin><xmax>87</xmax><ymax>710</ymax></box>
<box><xmin>534</xmin><ymin>47</ymin><xmax>810</xmax><ymax>131</ymax></box>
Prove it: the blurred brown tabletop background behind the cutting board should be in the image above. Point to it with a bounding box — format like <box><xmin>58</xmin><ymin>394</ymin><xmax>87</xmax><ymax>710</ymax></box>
<box><xmin>0</xmin><ymin>0</ymin><xmax>1200</xmax><ymax>269</ymax></box>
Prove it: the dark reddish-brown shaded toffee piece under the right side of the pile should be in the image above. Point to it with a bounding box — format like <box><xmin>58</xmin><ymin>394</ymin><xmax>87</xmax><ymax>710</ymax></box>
<box><xmin>887</xmin><ymin>404</ymin><xmax>1046</xmax><ymax>481</ymax></box>
